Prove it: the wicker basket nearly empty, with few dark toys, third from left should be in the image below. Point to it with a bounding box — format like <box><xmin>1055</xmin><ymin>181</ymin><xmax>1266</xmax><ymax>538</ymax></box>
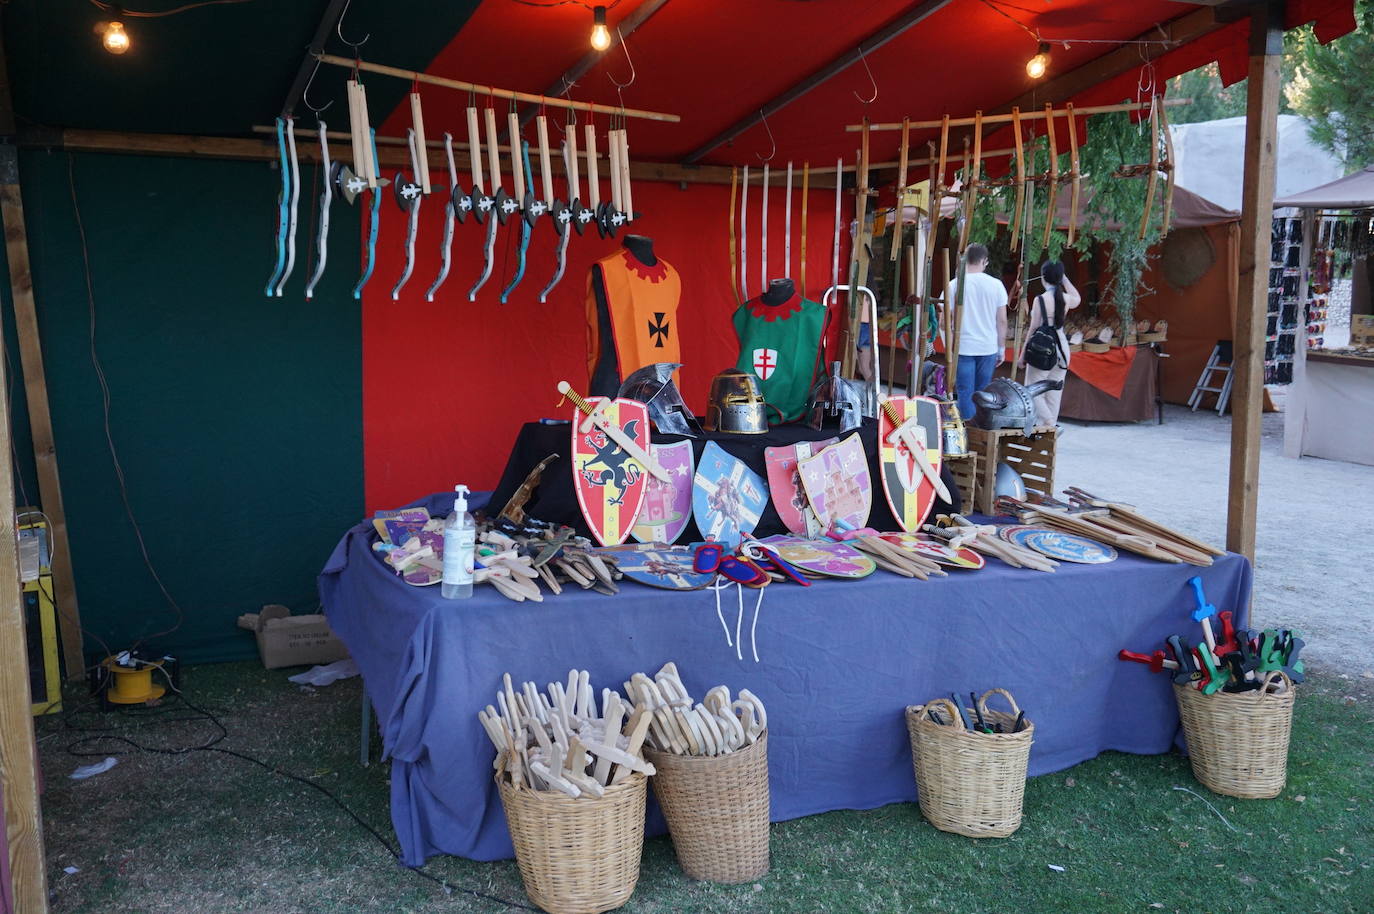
<box><xmin>907</xmin><ymin>689</ymin><xmax>1035</xmax><ymax>838</ymax></box>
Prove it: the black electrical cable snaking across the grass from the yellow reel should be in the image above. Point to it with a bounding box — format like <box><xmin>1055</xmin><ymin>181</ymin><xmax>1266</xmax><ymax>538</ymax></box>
<box><xmin>54</xmin><ymin>673</ymin><xmax>540</xmax><ymax>911</ymax></box>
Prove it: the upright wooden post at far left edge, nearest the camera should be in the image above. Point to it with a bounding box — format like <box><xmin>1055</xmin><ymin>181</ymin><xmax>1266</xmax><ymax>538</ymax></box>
<box><xmin>0</xmin><ymin>151</ymin><xmax>49</xmax><ymax>914</ymax></box>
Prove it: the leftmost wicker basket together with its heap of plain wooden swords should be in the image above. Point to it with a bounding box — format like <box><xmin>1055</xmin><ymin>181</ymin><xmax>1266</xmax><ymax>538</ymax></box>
<box><xmin>478</xmin><ymin>669</ymin><xmax>654</xmax><ymax>914</ymax></box>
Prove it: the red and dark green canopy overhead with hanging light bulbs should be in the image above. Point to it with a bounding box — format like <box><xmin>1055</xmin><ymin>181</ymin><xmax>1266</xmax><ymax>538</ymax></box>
<box><xmin>3</xmin><ymin>0</ymin><xmax>1355</xmax><ymax>166</ymax></box>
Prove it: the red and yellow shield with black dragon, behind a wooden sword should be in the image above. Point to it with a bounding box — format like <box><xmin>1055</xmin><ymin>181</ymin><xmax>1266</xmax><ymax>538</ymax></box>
<box><xmin>573</xmin><ymin>397</ymin><xmax>649</xmax><ymax>546</ymax></box>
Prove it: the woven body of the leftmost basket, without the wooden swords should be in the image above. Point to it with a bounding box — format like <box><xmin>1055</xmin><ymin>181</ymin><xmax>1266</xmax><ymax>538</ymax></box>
<box><xmin>496</xmin><ymin>774</ymin><xmax>649</xmax><ymax>914</ymax></box>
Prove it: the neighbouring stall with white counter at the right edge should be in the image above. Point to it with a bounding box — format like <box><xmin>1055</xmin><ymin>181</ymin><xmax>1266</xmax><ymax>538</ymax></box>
<box><xmin>1270</xmin><ymin>166</ymin><xmax>1374</xmax><ymax>465</ymax></box>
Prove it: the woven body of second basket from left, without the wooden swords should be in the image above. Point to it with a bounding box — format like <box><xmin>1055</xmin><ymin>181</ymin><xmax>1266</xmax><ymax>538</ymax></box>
<box><xmin>644</xmin><ymin>730</ymin><xmax>768</xmax><ymax>882</ymax></box>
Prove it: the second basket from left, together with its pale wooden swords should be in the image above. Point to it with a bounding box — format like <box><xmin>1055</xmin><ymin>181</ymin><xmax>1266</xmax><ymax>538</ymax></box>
<box><xmin>625</xmin><ymin>662</ymin><xmax>769</xmax><ymax>882</ymax></box>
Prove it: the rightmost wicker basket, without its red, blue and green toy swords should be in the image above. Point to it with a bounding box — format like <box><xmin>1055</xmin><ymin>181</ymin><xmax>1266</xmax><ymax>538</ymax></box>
<box><xmin>1173</xmin><ymin>672</ymin><xmax>1296</xmax><ymax>800</ymax></box>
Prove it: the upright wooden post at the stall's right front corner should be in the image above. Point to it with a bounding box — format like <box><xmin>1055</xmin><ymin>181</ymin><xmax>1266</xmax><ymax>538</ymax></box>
<box><xmin>1226</xmin><ymin>0</ymin><xmax>1285</xmax><ymax>562</ymax></box>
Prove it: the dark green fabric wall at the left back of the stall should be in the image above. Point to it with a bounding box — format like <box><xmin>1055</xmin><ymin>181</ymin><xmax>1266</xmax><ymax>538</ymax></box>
<box><xmin>4</xmin><ymin>151</ymin><xmax>363</xmax><ymax>661</ymax></box>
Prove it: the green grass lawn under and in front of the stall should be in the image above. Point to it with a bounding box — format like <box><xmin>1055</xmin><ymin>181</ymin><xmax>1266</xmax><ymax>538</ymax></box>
<box><xmin>32</xmin><ymin>662</ymin><xmax>1374</xmax><ymax>914</ymax></box>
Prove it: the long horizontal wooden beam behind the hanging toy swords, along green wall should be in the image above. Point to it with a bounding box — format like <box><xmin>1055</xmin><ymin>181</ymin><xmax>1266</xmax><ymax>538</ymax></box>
<box><xmin>19</xmin><ymin>128</ymin><xmax>852</xmax><ymax>190</ymax></box>
